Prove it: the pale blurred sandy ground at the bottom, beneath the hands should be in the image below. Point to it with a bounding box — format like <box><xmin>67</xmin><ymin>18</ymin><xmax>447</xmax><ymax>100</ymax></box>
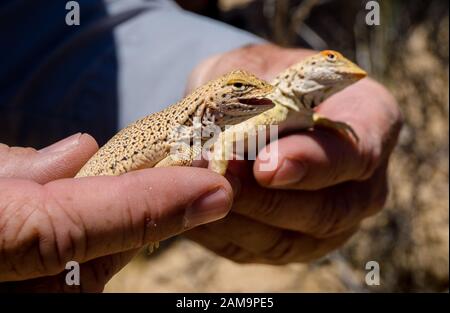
<box><xmin>105</xmin><ymin>240</ymin><xmax>356</xmax><ymax>292</ymax></box>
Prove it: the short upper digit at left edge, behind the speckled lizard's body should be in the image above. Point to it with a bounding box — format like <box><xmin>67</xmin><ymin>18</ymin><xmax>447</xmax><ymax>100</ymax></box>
<box><xmin>0</xmin><ymin>133</ymin><xmax>98</xmax><ymax>184</ymax></box>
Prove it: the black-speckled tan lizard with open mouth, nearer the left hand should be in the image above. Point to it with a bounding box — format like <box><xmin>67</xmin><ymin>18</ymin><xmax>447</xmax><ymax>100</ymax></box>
<box><xmin>75</xmin><ymin>71</ymin><xmax>274</xmax><ymax>177</ymax></box>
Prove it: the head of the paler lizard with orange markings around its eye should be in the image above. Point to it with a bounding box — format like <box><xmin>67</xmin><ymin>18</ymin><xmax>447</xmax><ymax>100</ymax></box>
<box><xmin>274</xmin><ymin>50</ymin><xmax>367</xmax><ymax>109</ymax></box>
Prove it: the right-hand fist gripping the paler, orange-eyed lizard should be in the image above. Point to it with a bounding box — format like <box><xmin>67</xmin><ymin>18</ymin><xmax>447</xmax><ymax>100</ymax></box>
<box><xmin>186</xmin><ymin>45</ymin><xmax>401</xmax><ymax>264</ymax></box>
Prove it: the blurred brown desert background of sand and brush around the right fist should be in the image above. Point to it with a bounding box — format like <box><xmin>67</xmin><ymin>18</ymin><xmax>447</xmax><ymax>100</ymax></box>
<box><xmin>105</xmin><ymin>0</ymin><xmax>449</xmax><ymax>292</ymax></box>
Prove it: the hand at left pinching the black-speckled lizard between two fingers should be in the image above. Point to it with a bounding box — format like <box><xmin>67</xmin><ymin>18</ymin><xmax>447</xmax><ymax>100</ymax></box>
<box><xmin>0</xmin><ymin>134</ymin><xmax>232</xmax><ymax>292</ymax></box>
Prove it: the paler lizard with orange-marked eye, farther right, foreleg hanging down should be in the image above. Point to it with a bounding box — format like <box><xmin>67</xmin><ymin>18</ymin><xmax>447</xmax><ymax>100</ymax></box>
<box><xmin>209</xmin><ymin>50</ymin><xmax>367</xmax><ymax>175</ymax></box>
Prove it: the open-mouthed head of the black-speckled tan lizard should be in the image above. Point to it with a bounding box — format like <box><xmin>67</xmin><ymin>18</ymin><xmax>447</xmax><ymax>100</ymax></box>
<box><xmin>209</xmin><ymin>70</ymin><xmax>274</xmax><ymax>127</ymax></box>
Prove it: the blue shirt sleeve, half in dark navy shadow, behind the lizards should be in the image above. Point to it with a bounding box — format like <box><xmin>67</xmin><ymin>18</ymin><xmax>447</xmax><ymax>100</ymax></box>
<box><xmin>0</xmin><ymin>0</ymin><xmax>262</xmax><ymax>147</ymax></box>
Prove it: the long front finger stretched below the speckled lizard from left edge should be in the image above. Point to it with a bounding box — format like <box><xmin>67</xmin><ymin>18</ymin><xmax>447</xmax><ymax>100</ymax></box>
<box><xmin>0</xmin><ymin>167</ymin><xmax>232</xmax><ymax>280</ymax></box>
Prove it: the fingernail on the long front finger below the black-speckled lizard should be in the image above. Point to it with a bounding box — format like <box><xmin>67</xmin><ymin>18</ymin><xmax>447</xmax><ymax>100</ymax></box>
<box><xmin>184</xmin><ymin>188</ymin><xmax>231</xmax><ymax>228</ymax></box>
